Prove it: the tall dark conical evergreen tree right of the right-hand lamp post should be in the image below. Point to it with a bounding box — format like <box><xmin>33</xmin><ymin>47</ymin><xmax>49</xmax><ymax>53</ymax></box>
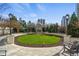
<box><xmin>68</xmin><ymin>13</ymin><xmax>79</xmax><ymax>37</ymax></box>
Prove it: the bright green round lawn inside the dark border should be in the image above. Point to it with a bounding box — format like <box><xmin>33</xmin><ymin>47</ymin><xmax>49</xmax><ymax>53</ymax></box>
<box><xmin>16</xmin><ymin>34</ymin><xmax>60</xmax><ymax>45</ymax></box>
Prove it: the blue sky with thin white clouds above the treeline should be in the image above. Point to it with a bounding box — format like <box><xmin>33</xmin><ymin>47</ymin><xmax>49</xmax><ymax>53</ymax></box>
<box><xmin>0</xmin><ymin>3</ymin><xmax>76</xmax><ymax>24</ymax></box>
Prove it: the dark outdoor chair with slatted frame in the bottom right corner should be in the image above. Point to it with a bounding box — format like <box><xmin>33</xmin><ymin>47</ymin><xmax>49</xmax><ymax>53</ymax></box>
<box><xmin>63</xmin><ymin>41</ymin><xmax>79</xmax><ymax>56</ymax></box>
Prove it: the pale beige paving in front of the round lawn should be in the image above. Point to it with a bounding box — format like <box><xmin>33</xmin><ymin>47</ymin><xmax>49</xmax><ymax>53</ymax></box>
<box><xmin>6</xmin><ymin>44</ymin><xmax>63</xmax><ymax>56</ymax></box>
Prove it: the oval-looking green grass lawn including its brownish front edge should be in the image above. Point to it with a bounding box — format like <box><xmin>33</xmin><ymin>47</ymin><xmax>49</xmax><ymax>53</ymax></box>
<box><xmin>15</xmin><ymin>34</ymin><xmax>61</xmax><ymax>47</ymax></box>
